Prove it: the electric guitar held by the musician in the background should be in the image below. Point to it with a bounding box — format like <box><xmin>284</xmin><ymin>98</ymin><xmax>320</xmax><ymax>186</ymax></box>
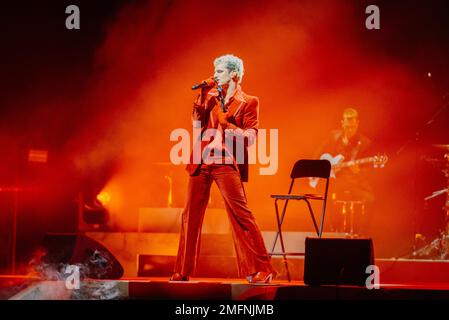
<box><xmin>309</xmin><ymin>153</ymin><xmax>388</xmax><ymax>188</ymax></box>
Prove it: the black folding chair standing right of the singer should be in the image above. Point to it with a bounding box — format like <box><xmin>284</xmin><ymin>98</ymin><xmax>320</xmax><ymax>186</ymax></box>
<box><xmin>270</xmin><ymin>160</ymin><xmax>331</xmax><ymax>282</ymax></box>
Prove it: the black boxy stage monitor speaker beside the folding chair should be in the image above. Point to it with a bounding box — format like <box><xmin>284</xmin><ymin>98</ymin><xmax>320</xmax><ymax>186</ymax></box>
<box><xmin>304</xmin><ymin>238</ymin><xmax>374</xmax><ymax>286</ymax></box>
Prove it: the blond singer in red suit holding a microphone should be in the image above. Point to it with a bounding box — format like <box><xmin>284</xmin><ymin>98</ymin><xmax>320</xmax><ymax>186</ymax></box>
<box><xmin>170</xmin><ymin>54</ymin><xmax>275</xmax><ymax>283</ymax></box>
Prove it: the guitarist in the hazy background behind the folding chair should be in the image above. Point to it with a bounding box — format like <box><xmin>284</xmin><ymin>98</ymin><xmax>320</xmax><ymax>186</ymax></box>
<box><xmin>316</xmin><ymin>108</ymin><xmax>374</xmax><ymax>235</ymax></box>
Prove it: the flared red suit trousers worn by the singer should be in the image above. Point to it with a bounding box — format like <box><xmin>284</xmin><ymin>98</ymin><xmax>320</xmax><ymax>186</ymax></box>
<box><xmin>174</xmin><ymin>164</ymin><xmax>272</xmax><ymax>277</ymax></box>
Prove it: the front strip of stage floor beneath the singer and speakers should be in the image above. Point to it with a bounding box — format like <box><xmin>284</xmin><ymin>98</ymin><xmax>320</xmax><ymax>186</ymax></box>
<box><xmin>0</xmin><ymin>276</ymin><xmax>449</xmax><ymax>300</ymax></box>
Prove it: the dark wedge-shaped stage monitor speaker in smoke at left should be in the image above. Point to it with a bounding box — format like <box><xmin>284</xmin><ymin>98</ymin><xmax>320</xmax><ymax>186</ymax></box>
<box><xmin>41</xmin><ymin>233</ymin><xmax>124</xmax><ymax>279</ymax></box>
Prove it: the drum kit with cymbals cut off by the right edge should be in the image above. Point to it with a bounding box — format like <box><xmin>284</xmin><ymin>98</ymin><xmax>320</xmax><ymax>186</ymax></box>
<box><xmin>412</xmin><ymin>144</ymin><xmax>449</xmax><ymax>260</ymax></box>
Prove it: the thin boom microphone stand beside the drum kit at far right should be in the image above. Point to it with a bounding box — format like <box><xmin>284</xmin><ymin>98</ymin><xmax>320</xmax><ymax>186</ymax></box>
<box><xmin>396</xmin><ymin>92</ymin><xmax>449</xmax><ymax>256</ymax></box>
